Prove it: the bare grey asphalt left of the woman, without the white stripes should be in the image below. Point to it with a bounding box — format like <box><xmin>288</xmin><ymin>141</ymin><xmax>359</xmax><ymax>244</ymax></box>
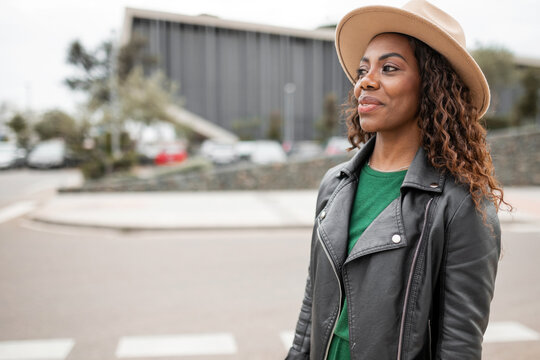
<box><xmin>0</xmin><ymin>220</ymin><xmax>309</xmax><ymax>359</ymax></box>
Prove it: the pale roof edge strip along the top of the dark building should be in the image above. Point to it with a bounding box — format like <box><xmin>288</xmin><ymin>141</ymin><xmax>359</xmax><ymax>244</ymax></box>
<box><xmin>121</xmin><ymin>7</ymin><xmax>335</xmax><ymax>44</ymax></box>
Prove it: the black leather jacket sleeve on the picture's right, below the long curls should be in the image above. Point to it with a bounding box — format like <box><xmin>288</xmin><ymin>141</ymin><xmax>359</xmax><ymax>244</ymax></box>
<box><xmin>435</xmin><ymin>195</ymin><xmax>501</xmax><ymax>360</ymax></box>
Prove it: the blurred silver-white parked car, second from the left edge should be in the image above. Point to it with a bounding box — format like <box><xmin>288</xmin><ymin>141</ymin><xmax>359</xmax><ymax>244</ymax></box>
<box><xmin>26</xmin><ymin>139</ymin><xmax>68</xmax><ymax>169</ymax></box>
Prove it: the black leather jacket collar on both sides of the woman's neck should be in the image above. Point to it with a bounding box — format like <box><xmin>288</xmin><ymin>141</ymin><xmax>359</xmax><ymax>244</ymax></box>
<box><xmin>338</xmin><ymin>136</ymin><xmax>445</xmax><ymax>193</ymax></box>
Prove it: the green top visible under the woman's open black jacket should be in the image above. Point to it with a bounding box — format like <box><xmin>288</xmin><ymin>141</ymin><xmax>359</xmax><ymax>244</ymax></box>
<box><xmin>328</xmin><ymin>164</ymin><xmax>407</xmax><ymax>360</ymax></box>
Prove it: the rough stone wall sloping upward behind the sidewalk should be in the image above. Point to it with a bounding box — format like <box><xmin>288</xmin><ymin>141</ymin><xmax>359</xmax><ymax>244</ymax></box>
<box><xmin>61</xmin><ymin>127</ymin><xmax>540</xmax><ymax>192</ymax></box>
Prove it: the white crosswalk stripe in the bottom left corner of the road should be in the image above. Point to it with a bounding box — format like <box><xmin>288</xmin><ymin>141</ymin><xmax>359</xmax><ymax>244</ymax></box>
<box><xmin>0</xmin><ymin>339</ymin><xmax>74</xmax><ymax>360</ymax></box>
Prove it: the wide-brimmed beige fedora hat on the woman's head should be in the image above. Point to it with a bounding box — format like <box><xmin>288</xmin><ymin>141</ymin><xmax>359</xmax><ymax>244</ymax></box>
<box><xmin>336</xmin><ymin>0</ymin><xmax>490</xmax><ymax>116</ymax></box>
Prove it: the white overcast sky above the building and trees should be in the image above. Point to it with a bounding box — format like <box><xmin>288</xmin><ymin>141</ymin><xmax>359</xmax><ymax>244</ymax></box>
<box><xmin>0</xmin><ymin>0</ymin><xmax>540</xmax><ymax>111</ymax></box>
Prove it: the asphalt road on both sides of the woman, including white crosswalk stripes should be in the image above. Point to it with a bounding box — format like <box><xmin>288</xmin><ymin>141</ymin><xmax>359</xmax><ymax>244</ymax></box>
<box><xmin>0</xmin><ymin>172</ymin><xmax>540</xmax><ymax>360</ymax></box>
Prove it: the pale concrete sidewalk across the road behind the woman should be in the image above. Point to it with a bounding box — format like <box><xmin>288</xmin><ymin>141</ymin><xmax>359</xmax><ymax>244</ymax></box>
<box><xmin>29</xmin><ymin>187</ymin><xmax>540</xmax><ymax>230</ymax></box>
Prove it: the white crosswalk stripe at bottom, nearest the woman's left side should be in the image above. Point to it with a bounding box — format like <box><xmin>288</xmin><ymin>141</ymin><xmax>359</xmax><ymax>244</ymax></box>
<box><xmin>116</xmin><ymin>333</ymin><xmax>237</xmax><ymax>358</ymax></box>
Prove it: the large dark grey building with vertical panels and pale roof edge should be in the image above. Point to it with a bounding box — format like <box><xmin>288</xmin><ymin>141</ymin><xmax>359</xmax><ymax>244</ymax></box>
<box><xmin>122</xmin><ymin>8</ymin><xmax>351</xmax><ymax>140</ymax></box>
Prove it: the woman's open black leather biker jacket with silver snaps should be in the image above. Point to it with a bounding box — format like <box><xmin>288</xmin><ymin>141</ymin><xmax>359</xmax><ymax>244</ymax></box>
<box><xmin>287</xmin><ymin>139</ymin><xmax>500</xmax><ymax>360</ymax></box>
